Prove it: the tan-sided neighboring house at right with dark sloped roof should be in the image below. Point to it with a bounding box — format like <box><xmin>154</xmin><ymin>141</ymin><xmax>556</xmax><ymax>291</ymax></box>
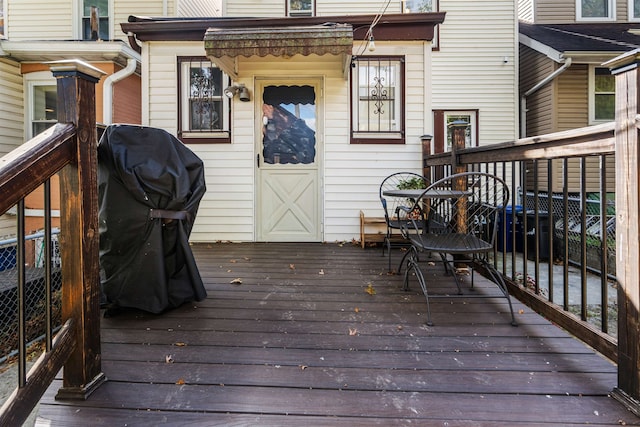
<box><xmin>519</xmin><ymin>0</ymin><xmax>640</xmax><ymax>192</ymax></box>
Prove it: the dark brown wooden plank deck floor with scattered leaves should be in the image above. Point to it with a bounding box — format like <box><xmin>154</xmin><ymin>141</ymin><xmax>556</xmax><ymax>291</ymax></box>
<box><xmin>36</xmin><ymin>243</ymin><xmax>640</xmax><ymax>427</ymax></box>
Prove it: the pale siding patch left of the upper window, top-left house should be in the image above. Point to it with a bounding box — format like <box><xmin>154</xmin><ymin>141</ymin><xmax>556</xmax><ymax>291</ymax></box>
<box><xmin>6</xmin><ymin>0</ymin><xmax>74</xmax><ymax>41</ymax></box>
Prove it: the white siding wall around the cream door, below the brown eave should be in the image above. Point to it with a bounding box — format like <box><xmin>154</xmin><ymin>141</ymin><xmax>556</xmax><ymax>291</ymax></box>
<box><xmin>142</xmin><ymin>42</ymin><xmax>431</xmax><ymax>241</ymax></box>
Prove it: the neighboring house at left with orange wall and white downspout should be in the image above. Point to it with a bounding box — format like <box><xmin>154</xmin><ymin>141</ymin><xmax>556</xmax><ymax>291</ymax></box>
<box><xmin>0</xmin><ymin>0</ymin><xmax>219</xmax><ymax>237</ymax></box>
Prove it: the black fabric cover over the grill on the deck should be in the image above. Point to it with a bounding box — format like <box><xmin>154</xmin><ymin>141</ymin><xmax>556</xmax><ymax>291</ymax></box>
<box><xmin>98</xmin><ymin>125</ymin><xmax>207</xmax><ymax>313</ymax></box>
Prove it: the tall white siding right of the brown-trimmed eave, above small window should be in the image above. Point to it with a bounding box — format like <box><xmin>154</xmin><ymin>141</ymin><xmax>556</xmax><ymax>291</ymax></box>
<box><xmin>432</xmin><ymin>0</ymin><xmax>518</xmax><ymax>145</ymax></box>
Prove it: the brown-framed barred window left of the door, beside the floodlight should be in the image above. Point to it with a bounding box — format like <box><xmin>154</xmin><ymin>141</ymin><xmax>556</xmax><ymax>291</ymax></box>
<box><xmin>178</xmin><ymin>58</ymin><xmax>231</xmax><ymax>143</ymax></box>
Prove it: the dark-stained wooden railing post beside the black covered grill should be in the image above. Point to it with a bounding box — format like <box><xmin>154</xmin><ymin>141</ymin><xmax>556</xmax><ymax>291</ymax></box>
<box><xmin>50</xmin><ymin>61</ymin><xmax>105</xmax><ymax>399</ymax></box>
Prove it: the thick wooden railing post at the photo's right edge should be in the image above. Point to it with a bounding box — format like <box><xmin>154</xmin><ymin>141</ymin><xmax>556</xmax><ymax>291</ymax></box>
<box><xmin>605</xmin><ymin>50</ymin><xmax>640</xmax><ymax>415</ymax></box>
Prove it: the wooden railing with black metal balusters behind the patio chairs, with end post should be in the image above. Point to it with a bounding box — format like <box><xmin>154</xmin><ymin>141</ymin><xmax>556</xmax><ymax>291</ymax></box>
<box><xmin>423</xmin><ymin>51</ymin><xmax>640</xmax><ymax>415</ymax></box>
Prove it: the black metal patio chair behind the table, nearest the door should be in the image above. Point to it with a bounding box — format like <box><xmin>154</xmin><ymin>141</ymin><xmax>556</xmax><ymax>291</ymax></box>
<box><xmin>379</xmin><ymin>172</ymin><xmax>429</xmax><ymax>271</ymax></box>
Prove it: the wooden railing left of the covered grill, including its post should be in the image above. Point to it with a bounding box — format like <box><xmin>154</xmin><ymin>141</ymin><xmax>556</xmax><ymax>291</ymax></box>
<box><xmin>0</xmin><ymin>61</ymin><xmax>105</xmax><ymax>425</ymax></box>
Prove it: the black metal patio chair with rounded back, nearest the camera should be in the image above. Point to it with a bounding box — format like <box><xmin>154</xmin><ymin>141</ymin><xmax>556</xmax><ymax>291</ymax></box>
<box><xmin>399</xmin><ymin>172</ymin><xmax>517</xmax><ymax>326</ymax></box>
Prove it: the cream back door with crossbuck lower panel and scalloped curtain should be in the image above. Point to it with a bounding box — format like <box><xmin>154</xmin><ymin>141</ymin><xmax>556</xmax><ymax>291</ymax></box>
<box><xmin>256</xmin><ymin>80</ymin><xmax>322</xmax><ymax>242</ymax></box>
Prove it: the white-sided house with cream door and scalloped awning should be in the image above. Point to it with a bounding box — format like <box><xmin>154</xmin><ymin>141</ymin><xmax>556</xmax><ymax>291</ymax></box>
<box><xmin>121</xmin><ymin>0</ymin><xmax>518</xmax><ymax>241</ymax></box>
